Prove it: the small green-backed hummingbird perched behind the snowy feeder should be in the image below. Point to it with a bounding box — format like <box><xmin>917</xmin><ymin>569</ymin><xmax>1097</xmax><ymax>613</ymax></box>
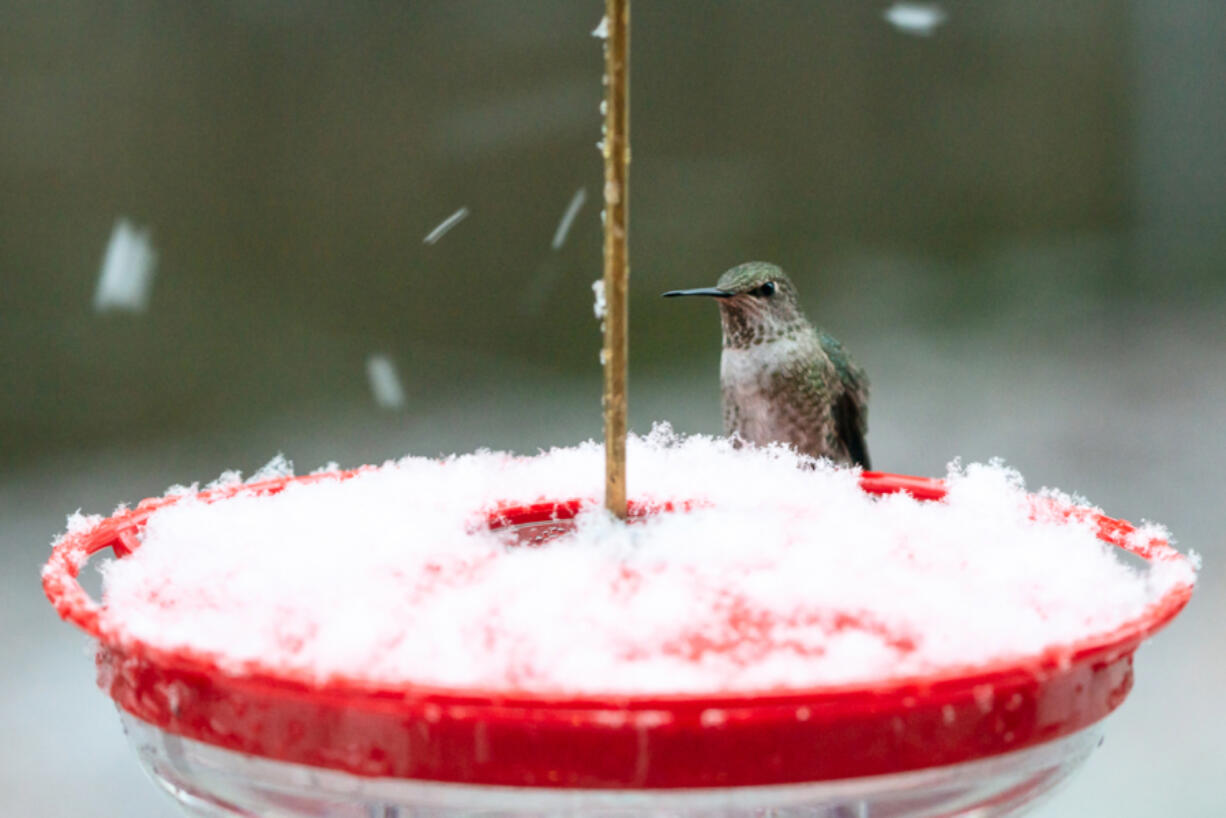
<box><xmin>663</xmin><ymin>261</ymin><xmax>870</xmax><ymax>468</ymax></box>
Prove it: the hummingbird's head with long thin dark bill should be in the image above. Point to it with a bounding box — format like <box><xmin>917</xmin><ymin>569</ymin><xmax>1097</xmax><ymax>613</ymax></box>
<box><xmin>664</xmin><ymin>261</ymin><xmax>809</xmax><ymax>347</ymax></box>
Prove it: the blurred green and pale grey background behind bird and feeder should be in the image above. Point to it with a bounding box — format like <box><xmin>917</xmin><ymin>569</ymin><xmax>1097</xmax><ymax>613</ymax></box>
<box><xmin>0</xmin><ymin>0</ymin><xmax>1226</xmax><ymax>818</ymax></box>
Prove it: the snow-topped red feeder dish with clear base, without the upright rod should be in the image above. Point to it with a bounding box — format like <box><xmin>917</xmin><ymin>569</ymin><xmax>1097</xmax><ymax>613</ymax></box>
<box><xmin>44</xmin><ymin>428</ymin><xmax>1194</xmax><ymax>816</ymax></box>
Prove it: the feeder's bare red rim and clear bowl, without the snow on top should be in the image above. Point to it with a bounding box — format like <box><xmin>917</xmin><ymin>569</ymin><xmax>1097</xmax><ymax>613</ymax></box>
<box><xmin>43</xmin><ymin>468</ymin><xmax>1192</xmax><ymax>817</ymax></box>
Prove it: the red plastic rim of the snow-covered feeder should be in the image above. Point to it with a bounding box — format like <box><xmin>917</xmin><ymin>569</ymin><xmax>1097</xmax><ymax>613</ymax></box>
<box><xmin>43</xmin><ymin>468</ymin><xmax>1192</xmax><ymax>789</ymax></box>
